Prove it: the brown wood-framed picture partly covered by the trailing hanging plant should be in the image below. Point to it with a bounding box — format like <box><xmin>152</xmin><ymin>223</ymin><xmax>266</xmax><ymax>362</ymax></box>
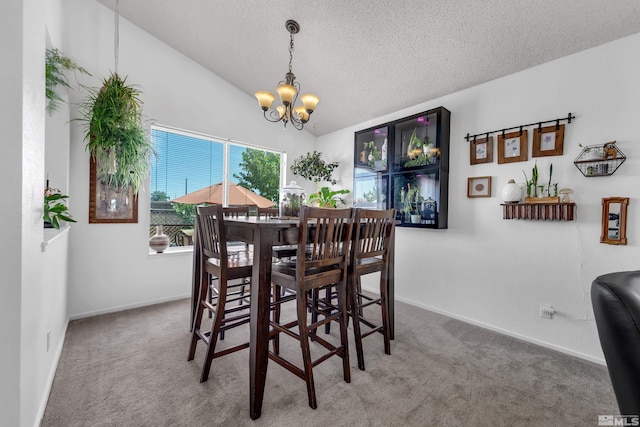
<box><xmin>89</xmin><ymin>158</ymin><xmax>138</xmax><ymax>224</ymax></box>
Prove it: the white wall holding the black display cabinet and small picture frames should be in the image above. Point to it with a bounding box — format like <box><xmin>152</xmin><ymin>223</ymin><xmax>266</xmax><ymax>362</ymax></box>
<box><xmin>318</xmin><ymin>34</ymin><xmax>640</xmax><ymax>363</ymax></box>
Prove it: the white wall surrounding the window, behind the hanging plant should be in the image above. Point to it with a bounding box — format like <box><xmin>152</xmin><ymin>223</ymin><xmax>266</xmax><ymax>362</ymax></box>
<box><xmin>62</xmin><ymin>0</ymin><xmax>313</xmax><ymax>321</ymax></box>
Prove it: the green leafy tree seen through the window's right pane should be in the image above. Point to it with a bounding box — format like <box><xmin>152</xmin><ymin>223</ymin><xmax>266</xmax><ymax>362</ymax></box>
<box><xmin>233</xmin><ymin>148</ymin><xmax>280</xmax><ymax>203</ymax></box>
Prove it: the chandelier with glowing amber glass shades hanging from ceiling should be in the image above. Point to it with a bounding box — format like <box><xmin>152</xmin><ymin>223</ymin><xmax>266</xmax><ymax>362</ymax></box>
<box><xmin>256</xmin><ymin>19</ymin><xmax>320</xmax><ymax>130</ymax></box>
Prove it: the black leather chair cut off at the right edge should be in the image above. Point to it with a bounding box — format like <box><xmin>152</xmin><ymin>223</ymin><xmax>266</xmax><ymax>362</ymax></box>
<box><xmin>591</xmin><ymin>271</ymin><xmax>640</xmax><ymax>415</ymax></box>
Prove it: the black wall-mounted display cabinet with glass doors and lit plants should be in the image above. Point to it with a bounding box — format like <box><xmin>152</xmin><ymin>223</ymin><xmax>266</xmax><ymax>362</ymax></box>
<box><xmin>353</xmin><ymin>107</ymin><xmax>451</xmax><ymax>228</ymax></box>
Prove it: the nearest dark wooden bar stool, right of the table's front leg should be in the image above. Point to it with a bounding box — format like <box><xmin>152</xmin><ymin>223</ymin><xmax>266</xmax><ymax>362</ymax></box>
<box><xmin>269</xmin><ymin>206</ymin><xmax>353</xmax><ymax>409</ymax></box>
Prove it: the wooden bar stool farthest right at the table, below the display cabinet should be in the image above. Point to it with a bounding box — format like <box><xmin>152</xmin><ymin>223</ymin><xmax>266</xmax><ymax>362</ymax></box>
<box><xmin>349</xmin><ymin>209</ymin><xmax>396</xmax><ymax>371</ymax></box>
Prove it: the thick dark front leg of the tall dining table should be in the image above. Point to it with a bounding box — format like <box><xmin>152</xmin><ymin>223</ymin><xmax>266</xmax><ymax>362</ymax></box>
<box><xmin>249</xmin><ymin>228</ymin><xmax>273</xmax><ymax>420</ymax></box>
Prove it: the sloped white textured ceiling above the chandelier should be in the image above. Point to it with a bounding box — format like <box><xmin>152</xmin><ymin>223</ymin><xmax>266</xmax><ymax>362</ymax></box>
<box><xmin>99</xmin><ymin>0</ymin><xmax>640</xmax><ymax>135</ymax></box>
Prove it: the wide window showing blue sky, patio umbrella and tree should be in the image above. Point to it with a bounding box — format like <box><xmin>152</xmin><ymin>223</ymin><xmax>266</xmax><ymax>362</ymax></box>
<box><xmin>150</xmin><ymin>126</ymin><xmax>284</xmax><ymax>246</ymax></box>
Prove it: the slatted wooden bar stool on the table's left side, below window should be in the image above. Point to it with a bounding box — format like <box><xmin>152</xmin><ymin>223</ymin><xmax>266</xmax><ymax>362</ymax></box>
<box><xmin>187</xmin><ymin>205</ymin><xmax>253</xmax><ymax>382</ymax></box>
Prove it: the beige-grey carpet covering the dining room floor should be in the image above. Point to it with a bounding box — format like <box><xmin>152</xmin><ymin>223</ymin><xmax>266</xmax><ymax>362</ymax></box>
<box><xmin>42</xmin><ymin>300</ymin><xmax>618</xmax><ymax>427</ymax></box>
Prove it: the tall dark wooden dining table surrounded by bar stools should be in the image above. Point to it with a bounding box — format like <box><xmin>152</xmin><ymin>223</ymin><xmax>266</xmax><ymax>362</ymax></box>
<box><xmin>191</xmin><ymin>216</ymin><xmax>395</xmax><ymax>420</ymax></box>
